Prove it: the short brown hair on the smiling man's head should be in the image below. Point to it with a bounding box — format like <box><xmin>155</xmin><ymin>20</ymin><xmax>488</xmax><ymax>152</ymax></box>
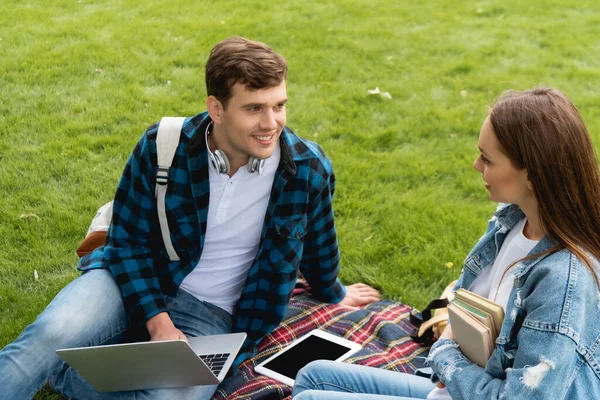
<box><xmin>205</xmin><ymin>36</ymin><xmax>287</xmax><ymax>108</ymax></box>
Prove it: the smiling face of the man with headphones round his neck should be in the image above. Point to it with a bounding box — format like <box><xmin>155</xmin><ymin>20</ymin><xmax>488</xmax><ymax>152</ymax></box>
<box><xmin>213</xmin><ymin>81</ymin><xmax>287</xmax><ymax>162</ymax></box>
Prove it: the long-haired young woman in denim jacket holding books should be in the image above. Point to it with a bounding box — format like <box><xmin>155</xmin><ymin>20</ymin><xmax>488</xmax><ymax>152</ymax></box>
<box><xmin>293</xmin><ymin>88</ymin><xmax>600</xmax><ymax>400</ymax></box>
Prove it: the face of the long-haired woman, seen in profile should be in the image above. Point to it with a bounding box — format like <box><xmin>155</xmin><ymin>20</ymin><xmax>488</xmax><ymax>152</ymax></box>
<box><xmin>473</xmin><ymin>117</ymin><xmax>535</xmax><ymax>208</ymax></box>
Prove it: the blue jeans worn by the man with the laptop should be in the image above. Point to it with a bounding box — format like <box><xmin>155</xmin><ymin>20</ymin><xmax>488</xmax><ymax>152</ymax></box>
<box><xmin>0</xmin><ymin>269</ymin><xmax>231</xmax><ymax>400</ymax></box>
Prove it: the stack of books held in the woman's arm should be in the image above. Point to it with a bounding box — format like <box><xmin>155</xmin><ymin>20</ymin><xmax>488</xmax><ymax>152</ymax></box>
<box><xmin>448</xmin><ymin>289</ymin><xmax>504</xmax><ymax>367</ymax></box>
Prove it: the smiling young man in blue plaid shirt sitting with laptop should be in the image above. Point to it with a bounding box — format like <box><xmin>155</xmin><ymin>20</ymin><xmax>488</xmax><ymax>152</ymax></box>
<box><xmin>0</xmin><ymin>37</ymin><xmax>379</xmax><ymax>400</ymax></box>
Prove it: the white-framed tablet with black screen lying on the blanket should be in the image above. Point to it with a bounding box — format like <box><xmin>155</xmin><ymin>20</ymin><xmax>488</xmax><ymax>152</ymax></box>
<box><xmin>254</xmin><ymin>329</ymin><xmax>362</xmax><ymax>386</ymax></box>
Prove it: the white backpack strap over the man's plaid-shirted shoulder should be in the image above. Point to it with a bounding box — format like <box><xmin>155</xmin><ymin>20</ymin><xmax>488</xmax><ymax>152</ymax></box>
<box><xmin>155</xmin><ymin>117</ymin><xmax>185</xmax><ymax>261</ymax></box>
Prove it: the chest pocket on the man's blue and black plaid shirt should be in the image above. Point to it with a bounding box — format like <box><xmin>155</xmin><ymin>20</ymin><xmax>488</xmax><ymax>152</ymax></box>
<box><xmin>269</xmin><ymin>215</ymin><xmax>307</xmax><ymax>272</ymax></box>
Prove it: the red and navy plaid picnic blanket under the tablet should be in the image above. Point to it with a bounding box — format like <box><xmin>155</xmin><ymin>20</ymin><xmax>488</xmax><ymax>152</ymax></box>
<box><xmin>212</xmin><ymin>279</ymin><xmax>429</xmax><ymax>400</ymax></box>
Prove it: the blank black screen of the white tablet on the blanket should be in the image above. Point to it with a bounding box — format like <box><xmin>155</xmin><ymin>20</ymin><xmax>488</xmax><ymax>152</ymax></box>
<box><xmin>264</xmin><ymin>335</ymin><xmax>350</xmax><ymax>379</ymax></box>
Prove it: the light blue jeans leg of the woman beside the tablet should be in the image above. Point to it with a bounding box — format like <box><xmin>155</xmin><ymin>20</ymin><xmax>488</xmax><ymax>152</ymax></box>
<box><xmin>292</xmin><ymin>361</ymin><xmax>435</xmax><ymax>400</ymax></box>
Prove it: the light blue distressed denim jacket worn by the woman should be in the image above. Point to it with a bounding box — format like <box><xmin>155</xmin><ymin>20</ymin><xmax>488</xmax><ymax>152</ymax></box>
<box><xmin>428</xmin><ymin>205</ymin><xmax>600</xmax><ymax>400</ymax></box>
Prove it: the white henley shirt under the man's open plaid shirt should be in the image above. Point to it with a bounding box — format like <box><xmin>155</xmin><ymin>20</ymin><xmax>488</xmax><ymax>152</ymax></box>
<box><xmin>181</xmin><ymin>143</ymin><xmax>281</xmax><ymax>314</ymax></box>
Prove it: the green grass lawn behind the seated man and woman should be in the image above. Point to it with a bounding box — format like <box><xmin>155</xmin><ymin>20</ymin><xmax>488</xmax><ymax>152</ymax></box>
<box><xmin>0</xmin><ymin>0</ymin><xmax>600</xmax><ymax>399</ymax></box>
